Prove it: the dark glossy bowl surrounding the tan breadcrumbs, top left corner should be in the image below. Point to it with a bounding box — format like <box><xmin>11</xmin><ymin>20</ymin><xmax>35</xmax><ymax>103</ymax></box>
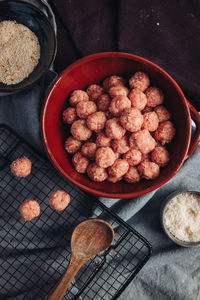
<box><xmin>0</xmin><ymin>1</ymin><xmax>57</xmax><ymax>92</ymax></box>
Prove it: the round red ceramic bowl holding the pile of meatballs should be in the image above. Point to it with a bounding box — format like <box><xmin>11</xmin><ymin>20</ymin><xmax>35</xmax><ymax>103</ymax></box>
<box><xmin>41</xmin><ymin>52</ymin><xmax>200</xmax><ymax>198</ymax></box>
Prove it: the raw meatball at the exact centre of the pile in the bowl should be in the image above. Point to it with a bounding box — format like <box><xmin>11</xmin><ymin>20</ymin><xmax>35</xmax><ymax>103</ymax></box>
<box><xmin>106</xmin><ymin>118</ymin><xmax>126</xmax><ymax>139</ymax></box>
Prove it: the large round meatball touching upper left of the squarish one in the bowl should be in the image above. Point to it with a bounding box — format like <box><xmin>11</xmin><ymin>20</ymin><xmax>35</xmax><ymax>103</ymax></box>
<box><xmin>120</xmin><ymin>107</ymin><xmax>143</xmax><ymax>132</ymax></box>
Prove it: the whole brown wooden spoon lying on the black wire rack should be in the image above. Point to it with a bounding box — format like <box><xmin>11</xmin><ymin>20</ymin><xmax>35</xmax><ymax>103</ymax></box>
<box><xmin>48</xmin><ymin>219</ymin><xmax>114</xmax><ymax>300</ymax></box>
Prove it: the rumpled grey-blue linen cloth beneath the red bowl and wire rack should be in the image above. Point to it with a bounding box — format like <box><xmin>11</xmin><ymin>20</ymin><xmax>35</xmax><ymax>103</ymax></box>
<box><xmin>0</xmin><ymin>1</ymin><xmax>200</xmax><ymax>300</ymax></box>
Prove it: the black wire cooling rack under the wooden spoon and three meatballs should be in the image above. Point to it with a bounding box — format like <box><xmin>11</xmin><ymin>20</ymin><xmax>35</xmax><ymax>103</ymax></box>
<box><xmin>0</xmin><ymin>125</ymin><xmax>151</xmax><ymax>300</ymax></box>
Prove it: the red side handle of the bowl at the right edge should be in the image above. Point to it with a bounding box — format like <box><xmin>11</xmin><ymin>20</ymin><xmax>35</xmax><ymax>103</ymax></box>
<box><xmin>186</xmin><ymin>99</ymin><xmax>200</xmax><ymax>159</ymax></box>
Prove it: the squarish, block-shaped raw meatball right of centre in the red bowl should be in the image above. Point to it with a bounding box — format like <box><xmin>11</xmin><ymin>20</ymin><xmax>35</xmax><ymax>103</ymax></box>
<box><xmin>129</xmin><ymin>129</ymin><xmax>156</xmax><ymax>154</ymax></box>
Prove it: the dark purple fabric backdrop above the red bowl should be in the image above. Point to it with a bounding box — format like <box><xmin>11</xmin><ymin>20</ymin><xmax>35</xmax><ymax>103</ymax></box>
<box><xmin>50</xmin><ymin>0</ymin><xmax>200</xmax><ymax>109</ymax></box>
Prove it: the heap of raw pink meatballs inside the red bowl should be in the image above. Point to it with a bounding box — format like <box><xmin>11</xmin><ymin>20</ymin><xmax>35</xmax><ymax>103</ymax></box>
<box><xmin>62</xmin><ymin>71</ymin><xmax>175</xmax><ymax>183</ymax></box>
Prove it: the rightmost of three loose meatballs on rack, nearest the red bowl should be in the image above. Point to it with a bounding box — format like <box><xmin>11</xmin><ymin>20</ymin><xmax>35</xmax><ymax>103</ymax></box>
<box><xmin>49</xmin><ymin>190</ymin><xmax>70</xmax><ymax>211</ymax></box>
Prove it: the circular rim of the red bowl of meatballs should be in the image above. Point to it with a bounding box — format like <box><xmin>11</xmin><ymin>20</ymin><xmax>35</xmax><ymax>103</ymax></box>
<box><xmin>41</xmin><ymin>52</ymin><xmax>191</xmax><ymax>199</ymax></box>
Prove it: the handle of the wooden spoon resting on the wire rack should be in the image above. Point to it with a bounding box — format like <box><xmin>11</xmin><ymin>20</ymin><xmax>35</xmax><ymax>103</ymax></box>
<box><xmin>47</xmin><ymin>255</ymin><xmax>86</xmax><ymax>300</ymax></box>
